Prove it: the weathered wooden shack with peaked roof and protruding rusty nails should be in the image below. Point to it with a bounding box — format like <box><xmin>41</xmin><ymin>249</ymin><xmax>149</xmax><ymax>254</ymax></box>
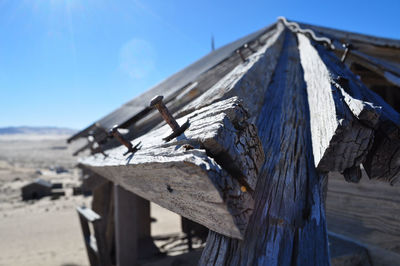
<box><xmin>69</xmin><ymin>18</ymin><xmax>400</xmax><ymax>265</ymax></box>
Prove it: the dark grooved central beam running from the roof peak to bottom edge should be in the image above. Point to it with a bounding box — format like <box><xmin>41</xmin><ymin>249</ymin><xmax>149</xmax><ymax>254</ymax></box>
<box><xmin>200</xmin><ymin>30</ymin><xmax>329</xmax><ymax>265</ymax></box>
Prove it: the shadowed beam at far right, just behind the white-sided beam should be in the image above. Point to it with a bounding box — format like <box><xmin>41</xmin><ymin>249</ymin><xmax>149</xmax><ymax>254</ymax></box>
<box><xmin>315</xmin><ymin>41</ymin><xmax>400</xmax><ymax>184</ymax></box>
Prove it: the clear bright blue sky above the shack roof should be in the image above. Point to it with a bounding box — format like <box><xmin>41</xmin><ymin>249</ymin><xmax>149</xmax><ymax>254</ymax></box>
<box><xmin>0</xmin><ymin>0</ymin><xmax>400</xmax><ymax>129</ymax></box>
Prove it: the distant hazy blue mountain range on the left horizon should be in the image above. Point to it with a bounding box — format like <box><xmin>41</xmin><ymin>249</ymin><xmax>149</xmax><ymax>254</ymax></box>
<box><xmin>0</xmin><ymin>126</ymin><xmax>77</xmax><ymax>135</ymax></box>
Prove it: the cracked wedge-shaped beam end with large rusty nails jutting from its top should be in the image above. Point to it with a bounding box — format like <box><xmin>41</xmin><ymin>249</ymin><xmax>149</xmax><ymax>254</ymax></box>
<box><xmin>80</xmin><ymin>98</ymin><xmax>264</xmax><ymax>238</ymax></box>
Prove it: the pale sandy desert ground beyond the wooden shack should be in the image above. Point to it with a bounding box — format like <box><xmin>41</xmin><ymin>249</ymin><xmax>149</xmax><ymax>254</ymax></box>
<box><xmin>0</xmin><ymin>135</ymin><xmax>184</xmax><ymax>266</ymax></box>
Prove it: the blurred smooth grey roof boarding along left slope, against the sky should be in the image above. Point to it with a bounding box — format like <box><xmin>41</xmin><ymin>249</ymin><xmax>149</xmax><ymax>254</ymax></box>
<box><xmin>68</xmin><ymin>24</ymin><xmax>276</xmax><ymax>144</ymax></box>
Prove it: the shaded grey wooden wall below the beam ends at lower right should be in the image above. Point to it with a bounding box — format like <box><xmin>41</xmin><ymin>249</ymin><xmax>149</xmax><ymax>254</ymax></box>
<box><xmin>326</xmin><ymin>172</ymin><xmax>400</xmax><ymax>254</ymax></box>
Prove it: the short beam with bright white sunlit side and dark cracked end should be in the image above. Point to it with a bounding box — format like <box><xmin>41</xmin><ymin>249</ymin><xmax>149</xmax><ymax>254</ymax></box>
<box><xmin>297</xmin><ymin>34</ymin><xmax>380</xmax><ymax>172</ymax></box>
